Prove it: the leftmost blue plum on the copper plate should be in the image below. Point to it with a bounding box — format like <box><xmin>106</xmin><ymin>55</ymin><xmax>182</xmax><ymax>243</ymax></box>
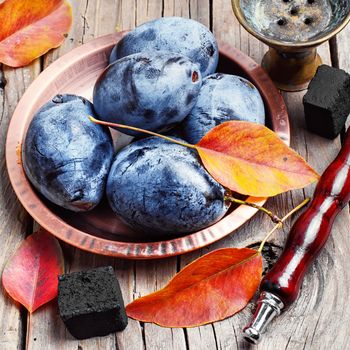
<box><xmin>22</xmin><ymin>95</ymin><xmax>114</xmax><ymax>211</ymax></box>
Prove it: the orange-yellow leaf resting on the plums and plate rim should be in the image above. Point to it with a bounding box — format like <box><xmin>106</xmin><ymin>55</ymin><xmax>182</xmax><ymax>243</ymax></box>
<box><xmin>196</xmin><ymin>121</ymin><xmax>319</xmax><ymax>197</ymax></box>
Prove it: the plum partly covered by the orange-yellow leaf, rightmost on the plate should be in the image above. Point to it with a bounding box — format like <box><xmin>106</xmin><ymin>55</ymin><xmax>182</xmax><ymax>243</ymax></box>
<box><xmin>178</xmin><ymin>73</ymin><xmax>265</xmax><ymax>144</ymax></box>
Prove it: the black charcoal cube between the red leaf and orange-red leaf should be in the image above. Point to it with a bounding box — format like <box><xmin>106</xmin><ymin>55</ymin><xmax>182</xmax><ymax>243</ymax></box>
<box><xmin>58</xmin><ymin>266</ymin><xmax>128</xmax><ymax>339</ymax></box>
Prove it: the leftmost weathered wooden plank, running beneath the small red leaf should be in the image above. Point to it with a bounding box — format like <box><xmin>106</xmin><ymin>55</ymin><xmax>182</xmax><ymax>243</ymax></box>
<box><xmin>0</xmin><ymin>55</ymin><xmax>40</xmax><ymax>350</ymax></box>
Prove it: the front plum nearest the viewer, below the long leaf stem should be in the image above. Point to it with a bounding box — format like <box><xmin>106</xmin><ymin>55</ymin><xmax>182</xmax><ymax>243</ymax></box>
<box><xmin>107</xmin><ymin>137</ymin><xmax>228</xmax><ymax>235</ymax></box>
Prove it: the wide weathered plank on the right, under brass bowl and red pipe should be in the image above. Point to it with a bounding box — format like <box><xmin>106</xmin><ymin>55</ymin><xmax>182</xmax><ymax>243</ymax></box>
<box><xmin>210</xmin><ymin>1</ymin><xmax>350</xmax><ymax>349</ymax></box>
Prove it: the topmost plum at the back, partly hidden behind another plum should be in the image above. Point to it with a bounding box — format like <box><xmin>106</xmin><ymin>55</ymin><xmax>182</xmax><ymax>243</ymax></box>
<box><xmin>109</xmin><ymin>17</ymin><xmax>219</xmax><ymax>77</ymax></box>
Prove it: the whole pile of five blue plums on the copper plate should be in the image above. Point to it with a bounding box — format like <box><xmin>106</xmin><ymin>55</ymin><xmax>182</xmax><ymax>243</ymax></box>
<box><xmin>22</xmin><ymin>17</ymin><xmax>265</xmax><ymax>234</ymax></box>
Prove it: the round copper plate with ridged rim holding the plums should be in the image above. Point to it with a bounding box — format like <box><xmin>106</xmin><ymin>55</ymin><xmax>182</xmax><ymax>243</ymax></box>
<box><xmin>6</xmin><ymin>33</ymin><xmax>290</xmax><ymax>259</ymax></box>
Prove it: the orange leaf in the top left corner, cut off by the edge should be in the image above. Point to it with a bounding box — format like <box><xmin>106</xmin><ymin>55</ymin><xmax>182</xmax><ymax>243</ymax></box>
<box><xmin>0</xmin><ymin>0</ymin><xmax>72</xmax><ymax>67</ymax></box>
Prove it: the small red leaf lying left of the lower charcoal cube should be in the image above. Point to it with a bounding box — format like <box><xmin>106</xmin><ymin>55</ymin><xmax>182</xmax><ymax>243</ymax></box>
<box><xmin>2</xmin><ymin>229</ymin><xmax>64</xmax><ymax>312</ymax></box>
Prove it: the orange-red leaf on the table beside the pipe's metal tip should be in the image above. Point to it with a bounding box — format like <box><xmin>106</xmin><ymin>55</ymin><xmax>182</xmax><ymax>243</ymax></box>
<box><xmin>126</xmin><ymin>248</ymin><xmax>262</xmax><ymax>327</ymax></box>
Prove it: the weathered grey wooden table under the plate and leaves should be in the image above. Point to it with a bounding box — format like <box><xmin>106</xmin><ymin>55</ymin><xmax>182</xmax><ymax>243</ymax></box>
<box><xmin>0</xmin><ymin>0</ymin><xmax>350</xmax><ymax>350</ymax></box>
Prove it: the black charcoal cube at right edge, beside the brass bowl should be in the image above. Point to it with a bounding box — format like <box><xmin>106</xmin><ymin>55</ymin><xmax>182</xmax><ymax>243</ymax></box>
<box><xmin>303</xmin><ymin>65</ymin><xmax>350</xmax><ymax>139</ymax></box>
